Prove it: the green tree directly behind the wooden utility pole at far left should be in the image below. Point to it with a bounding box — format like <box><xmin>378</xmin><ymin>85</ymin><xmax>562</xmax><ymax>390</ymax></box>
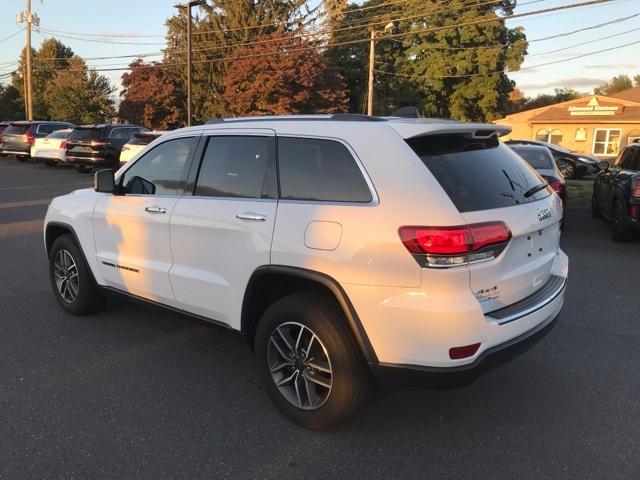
<box><xmin>12</xmin><ymin>38</ymin><xmax>74</xmax><ymax>120</ymax></box>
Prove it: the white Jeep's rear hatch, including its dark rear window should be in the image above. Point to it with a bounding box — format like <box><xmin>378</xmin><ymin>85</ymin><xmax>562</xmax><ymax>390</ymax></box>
<box><xmin>406</xmin><ymin>131</ymin><xmax>562</xmax><ymax>313</ymax></box>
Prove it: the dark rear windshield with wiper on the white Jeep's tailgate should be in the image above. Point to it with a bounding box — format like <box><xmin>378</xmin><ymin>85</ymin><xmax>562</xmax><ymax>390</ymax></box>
<box><xmin>407</xmin><ymin>135</ymin><xmax>550</xmax><ymax>212</ymax></box>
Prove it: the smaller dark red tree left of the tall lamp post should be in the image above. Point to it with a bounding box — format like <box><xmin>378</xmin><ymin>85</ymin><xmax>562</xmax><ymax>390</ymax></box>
<box><xmin>118</xmin><ymin>59</ymin><xmax>185</xmax><ymax>130</ymax></box>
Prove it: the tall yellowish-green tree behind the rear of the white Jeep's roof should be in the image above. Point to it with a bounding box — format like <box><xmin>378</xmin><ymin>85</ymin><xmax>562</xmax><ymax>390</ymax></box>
<box><xmin>401</xmin><ymin>0</ymin><xmax>527</xmax><ymax>121</ymax></box>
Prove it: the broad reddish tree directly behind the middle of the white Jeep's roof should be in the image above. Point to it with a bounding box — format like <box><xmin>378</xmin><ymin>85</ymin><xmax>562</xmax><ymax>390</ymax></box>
<box><xmin>224</xmin><ymin>35</ymin><xmax>348</xmax><ymax>115</ymax></box>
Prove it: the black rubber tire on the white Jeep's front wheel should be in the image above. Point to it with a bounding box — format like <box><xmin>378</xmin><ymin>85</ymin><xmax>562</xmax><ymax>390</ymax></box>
<box><xmin>49</xmin><ymin>234</ymin><xmax>105</xmax><ymax>315</ymax></box>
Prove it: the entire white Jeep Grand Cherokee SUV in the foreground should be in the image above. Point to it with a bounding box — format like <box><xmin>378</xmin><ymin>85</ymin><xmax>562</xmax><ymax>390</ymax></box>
<box><xmin>44</xmin><ymin>115</ymin><xmax>568</xmax><ymax>428</ymax></box>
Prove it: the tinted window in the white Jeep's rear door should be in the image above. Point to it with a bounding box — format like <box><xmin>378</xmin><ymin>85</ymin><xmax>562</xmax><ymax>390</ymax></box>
<box><xmin>194</xmin><ymin>135</ymin><xmax>273</xmax><ymax>198</ymax></box>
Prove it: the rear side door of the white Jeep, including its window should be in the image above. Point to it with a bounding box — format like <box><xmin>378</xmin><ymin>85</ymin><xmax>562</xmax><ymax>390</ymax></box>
<box><xmin>170</xmin><ymin>129</ymin><xmax>277</xmax><ymax>328</ymax></box>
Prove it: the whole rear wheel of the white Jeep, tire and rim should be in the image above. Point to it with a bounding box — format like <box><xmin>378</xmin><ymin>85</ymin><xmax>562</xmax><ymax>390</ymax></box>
<box><xmin>255</xmin><ymin>293</ymin><xmax>371</xmax><ymax>430</ymax></box>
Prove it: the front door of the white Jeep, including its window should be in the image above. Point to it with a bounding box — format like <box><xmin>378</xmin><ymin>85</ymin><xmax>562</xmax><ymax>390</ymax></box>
<box><xmin>93</xmin><ymin>133</ymin><xmax>199</xmax><ymax>306</ymax></box>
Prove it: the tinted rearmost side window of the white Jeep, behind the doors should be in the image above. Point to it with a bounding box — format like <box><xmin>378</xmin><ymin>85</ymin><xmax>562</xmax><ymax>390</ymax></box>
<box><xmin>278</xmin><ymin>137</ymin><xmax>372</xmax><ymax>203</ymax></box>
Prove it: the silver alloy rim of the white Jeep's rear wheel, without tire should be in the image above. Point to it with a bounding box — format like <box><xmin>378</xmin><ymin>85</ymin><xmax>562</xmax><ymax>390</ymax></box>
<box><xmin>267</xmin><ymin>322</ymin><xmax>333</xmax><ymax>410</ymax></box>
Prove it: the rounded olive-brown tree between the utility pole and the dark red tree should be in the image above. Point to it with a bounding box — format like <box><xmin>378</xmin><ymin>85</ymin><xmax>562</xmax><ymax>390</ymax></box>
<box><xmin>43</xmin><ymin>58</ymin><xmax>115</xmax><ymax>124</ymax></box>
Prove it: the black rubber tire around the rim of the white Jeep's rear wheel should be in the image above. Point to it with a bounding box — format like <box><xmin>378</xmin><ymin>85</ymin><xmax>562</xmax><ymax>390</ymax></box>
<box><xmin>255</xmin><ymin>293</ymin><xmax>371</xmax><ymax>430</ymax></box>
